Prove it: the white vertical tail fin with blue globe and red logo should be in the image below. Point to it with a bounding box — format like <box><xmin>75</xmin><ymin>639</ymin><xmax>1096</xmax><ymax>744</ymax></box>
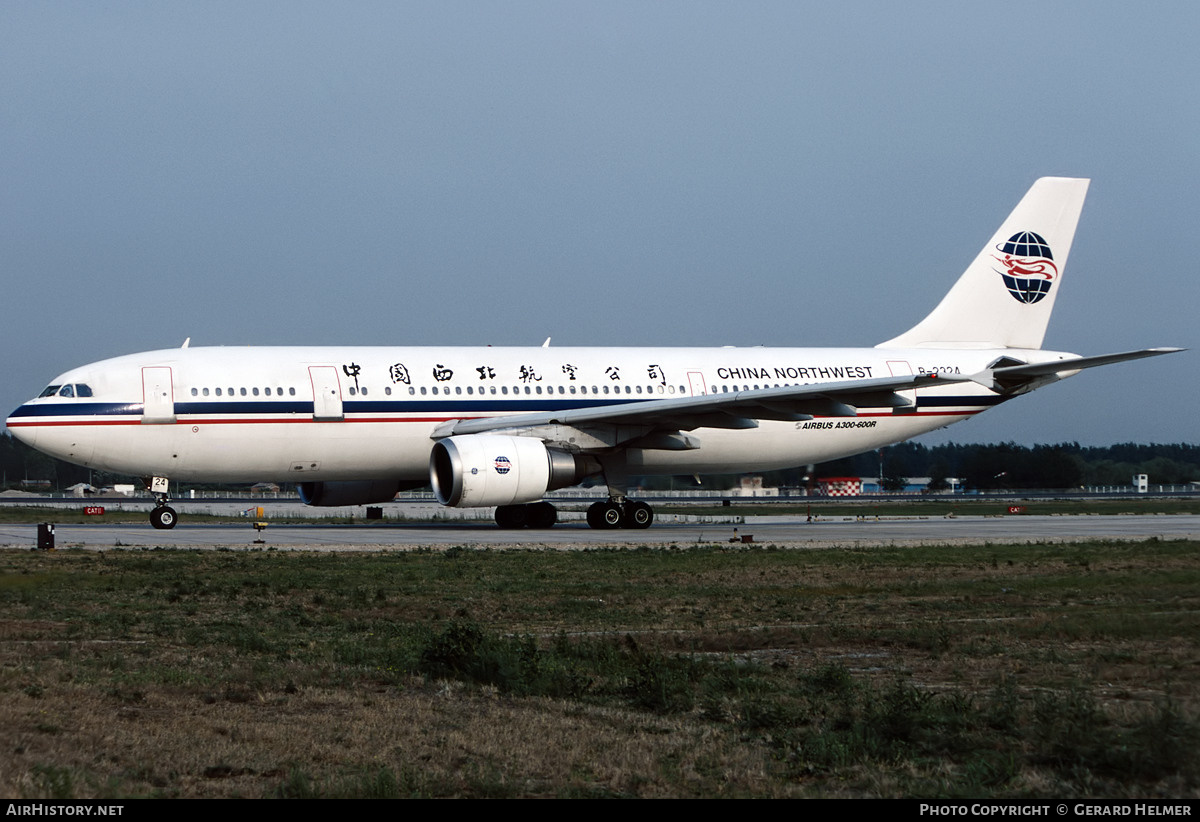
<box><xmin>876</xmin><ymin>176</ymin><xmax>1088</xmax><ymax>348</ymax></box>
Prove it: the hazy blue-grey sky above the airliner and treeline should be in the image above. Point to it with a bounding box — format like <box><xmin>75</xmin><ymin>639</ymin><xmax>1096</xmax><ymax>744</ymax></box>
<box><xmin>0</xmin><ymin>0</ymin><xmax>1200</xmax><ymax>445</ymax></box>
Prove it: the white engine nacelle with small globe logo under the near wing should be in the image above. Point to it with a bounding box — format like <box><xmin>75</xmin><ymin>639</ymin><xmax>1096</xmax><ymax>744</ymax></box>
<box><xmin>430</xmin><ymin>434</ymin><xmax>599</xmax><ymax>508</ymax></box>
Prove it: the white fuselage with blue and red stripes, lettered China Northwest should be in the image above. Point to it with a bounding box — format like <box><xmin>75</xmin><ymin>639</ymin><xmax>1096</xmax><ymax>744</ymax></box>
<box><xmin>0</xmin><ymin>347</ymin><xmax>1062</xmax><ymax>482</ymax></box>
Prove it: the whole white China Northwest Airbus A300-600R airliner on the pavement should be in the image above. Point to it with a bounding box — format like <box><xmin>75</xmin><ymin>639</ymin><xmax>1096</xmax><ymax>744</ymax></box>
<box><xmin>6</xmin><ymin>178</ymin><xmax>1181</xmax><ymax>528</ymax></box>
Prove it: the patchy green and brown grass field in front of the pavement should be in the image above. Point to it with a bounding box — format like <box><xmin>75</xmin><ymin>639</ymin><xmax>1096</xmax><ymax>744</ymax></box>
<box><xmin>0</xmin><ymin>541</ymin><xmax>1200</xmax><ymax>798</ymax></box>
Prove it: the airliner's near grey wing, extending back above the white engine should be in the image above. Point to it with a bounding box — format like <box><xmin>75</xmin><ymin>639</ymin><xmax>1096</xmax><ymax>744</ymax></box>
<box><xmin>432</xmin><ymin>374</ymin><xmax>971</xmax><ymax>439</ymax></box>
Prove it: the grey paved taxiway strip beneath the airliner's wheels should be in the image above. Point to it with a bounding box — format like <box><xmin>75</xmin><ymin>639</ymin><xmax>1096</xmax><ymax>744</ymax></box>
<box><xmin>0</xmin><ymin>515</ymin><xmax>1200</xmax><ymax>551</ymax></box>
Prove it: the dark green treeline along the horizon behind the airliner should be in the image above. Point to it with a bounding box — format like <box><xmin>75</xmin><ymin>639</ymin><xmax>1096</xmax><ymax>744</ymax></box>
<box><xmin>0</xmin><ymin>431</ymin><xmax>1200</xmax><ymax>491</ymax></box>
